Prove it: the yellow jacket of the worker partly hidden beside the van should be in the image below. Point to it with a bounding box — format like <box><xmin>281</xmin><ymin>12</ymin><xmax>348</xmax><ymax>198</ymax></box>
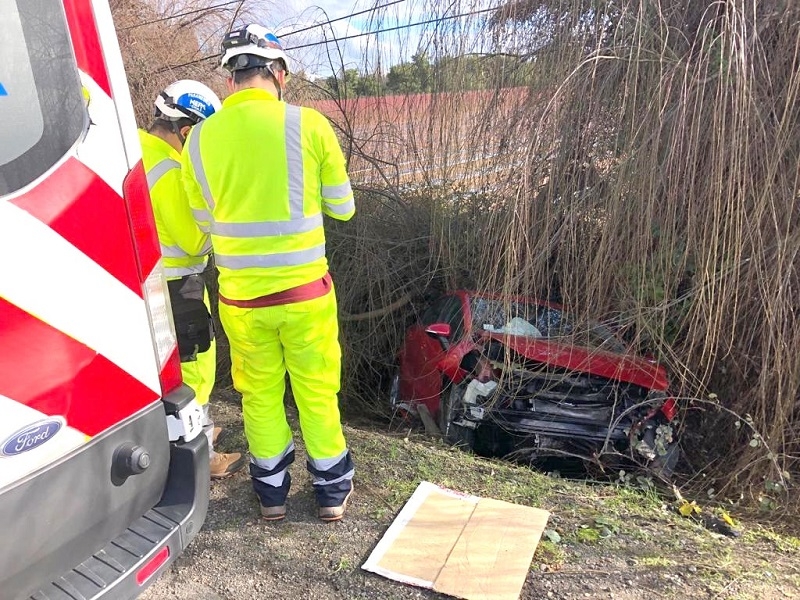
<box><xmin>139</xmin><ymin>129</ymin><xmax>211</xmax><ymax>279</ymax></box>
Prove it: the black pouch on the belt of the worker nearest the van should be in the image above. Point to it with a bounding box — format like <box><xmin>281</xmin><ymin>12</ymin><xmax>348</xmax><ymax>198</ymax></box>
<box><xmin>167</xmin><ymin>275</ymin><xmax>214</xmax><ymax>362</ymax></box>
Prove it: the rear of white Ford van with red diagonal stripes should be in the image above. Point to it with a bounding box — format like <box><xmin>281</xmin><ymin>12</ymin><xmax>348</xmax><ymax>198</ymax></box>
<box><xmin>0</xmin><ymin>0</ymin><xmax>208</xmax><ymax>599</ymax></box>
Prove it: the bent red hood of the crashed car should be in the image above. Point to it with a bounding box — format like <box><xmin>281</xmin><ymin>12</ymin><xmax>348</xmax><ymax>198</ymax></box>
<box><xmin>488</xmin><ymin>333</ymin><xmax>669</xmax><ymax>391</ymax></box>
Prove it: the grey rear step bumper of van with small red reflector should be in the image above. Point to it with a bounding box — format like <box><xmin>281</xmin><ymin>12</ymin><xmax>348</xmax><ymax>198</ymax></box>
<box><xmin>24</xmin><ymin>435</ymin><xmax>209</xmax><ymax>600</ymax></box>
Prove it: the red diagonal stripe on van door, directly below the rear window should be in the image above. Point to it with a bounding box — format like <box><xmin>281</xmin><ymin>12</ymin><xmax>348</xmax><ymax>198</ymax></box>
<box><xmin>11</xmin><ymin>158</ymin><xmax>143</xmax><ymax>298</ymax></box>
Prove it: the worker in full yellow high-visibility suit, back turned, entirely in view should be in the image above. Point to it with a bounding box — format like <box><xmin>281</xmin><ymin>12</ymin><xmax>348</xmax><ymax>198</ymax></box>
<box><xmin>182</xmin><ymin>25</ymin><xmax>355</xmax><ymax>521</ymax></box>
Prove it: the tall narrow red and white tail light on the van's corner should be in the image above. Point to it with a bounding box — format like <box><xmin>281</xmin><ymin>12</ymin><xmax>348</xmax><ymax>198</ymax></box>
<box><xmin>122</xmin><ymin>160</ymin><xmax>182</xmax><ymax>395</ymax></box>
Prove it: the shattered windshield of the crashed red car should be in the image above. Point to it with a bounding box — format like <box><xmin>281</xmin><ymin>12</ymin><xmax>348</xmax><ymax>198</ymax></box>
<box><xmin>470</xmin><ymin>296</ymin><xmax>625</xmax><ymax>353</ymax></box>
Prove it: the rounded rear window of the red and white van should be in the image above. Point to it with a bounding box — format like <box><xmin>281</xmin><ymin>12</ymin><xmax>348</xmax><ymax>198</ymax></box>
<box><xmin>0</xmin><ymin>0</ymin><xmax>88</xmax><ymax>196</ymax></box>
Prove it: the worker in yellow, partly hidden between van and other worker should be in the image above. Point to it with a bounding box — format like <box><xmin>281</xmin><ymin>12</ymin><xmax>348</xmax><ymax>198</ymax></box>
<box><xmin>139</xmin><ymin>80</ymin><xmax>246</xmax><ymax>479</ymax></box>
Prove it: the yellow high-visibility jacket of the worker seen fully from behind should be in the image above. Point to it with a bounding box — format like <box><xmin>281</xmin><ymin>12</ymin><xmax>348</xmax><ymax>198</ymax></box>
<box><xmin>181</xmin><ymin>89</ymin><xmax>355</xmax><ymax>300</ymax></box>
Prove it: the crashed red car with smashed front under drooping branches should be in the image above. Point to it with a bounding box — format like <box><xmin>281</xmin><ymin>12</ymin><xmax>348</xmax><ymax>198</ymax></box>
<box><xmin>390</xmin><ymin>291</ymin><xmax>679</xmax><ymax>476</ymax></box>
